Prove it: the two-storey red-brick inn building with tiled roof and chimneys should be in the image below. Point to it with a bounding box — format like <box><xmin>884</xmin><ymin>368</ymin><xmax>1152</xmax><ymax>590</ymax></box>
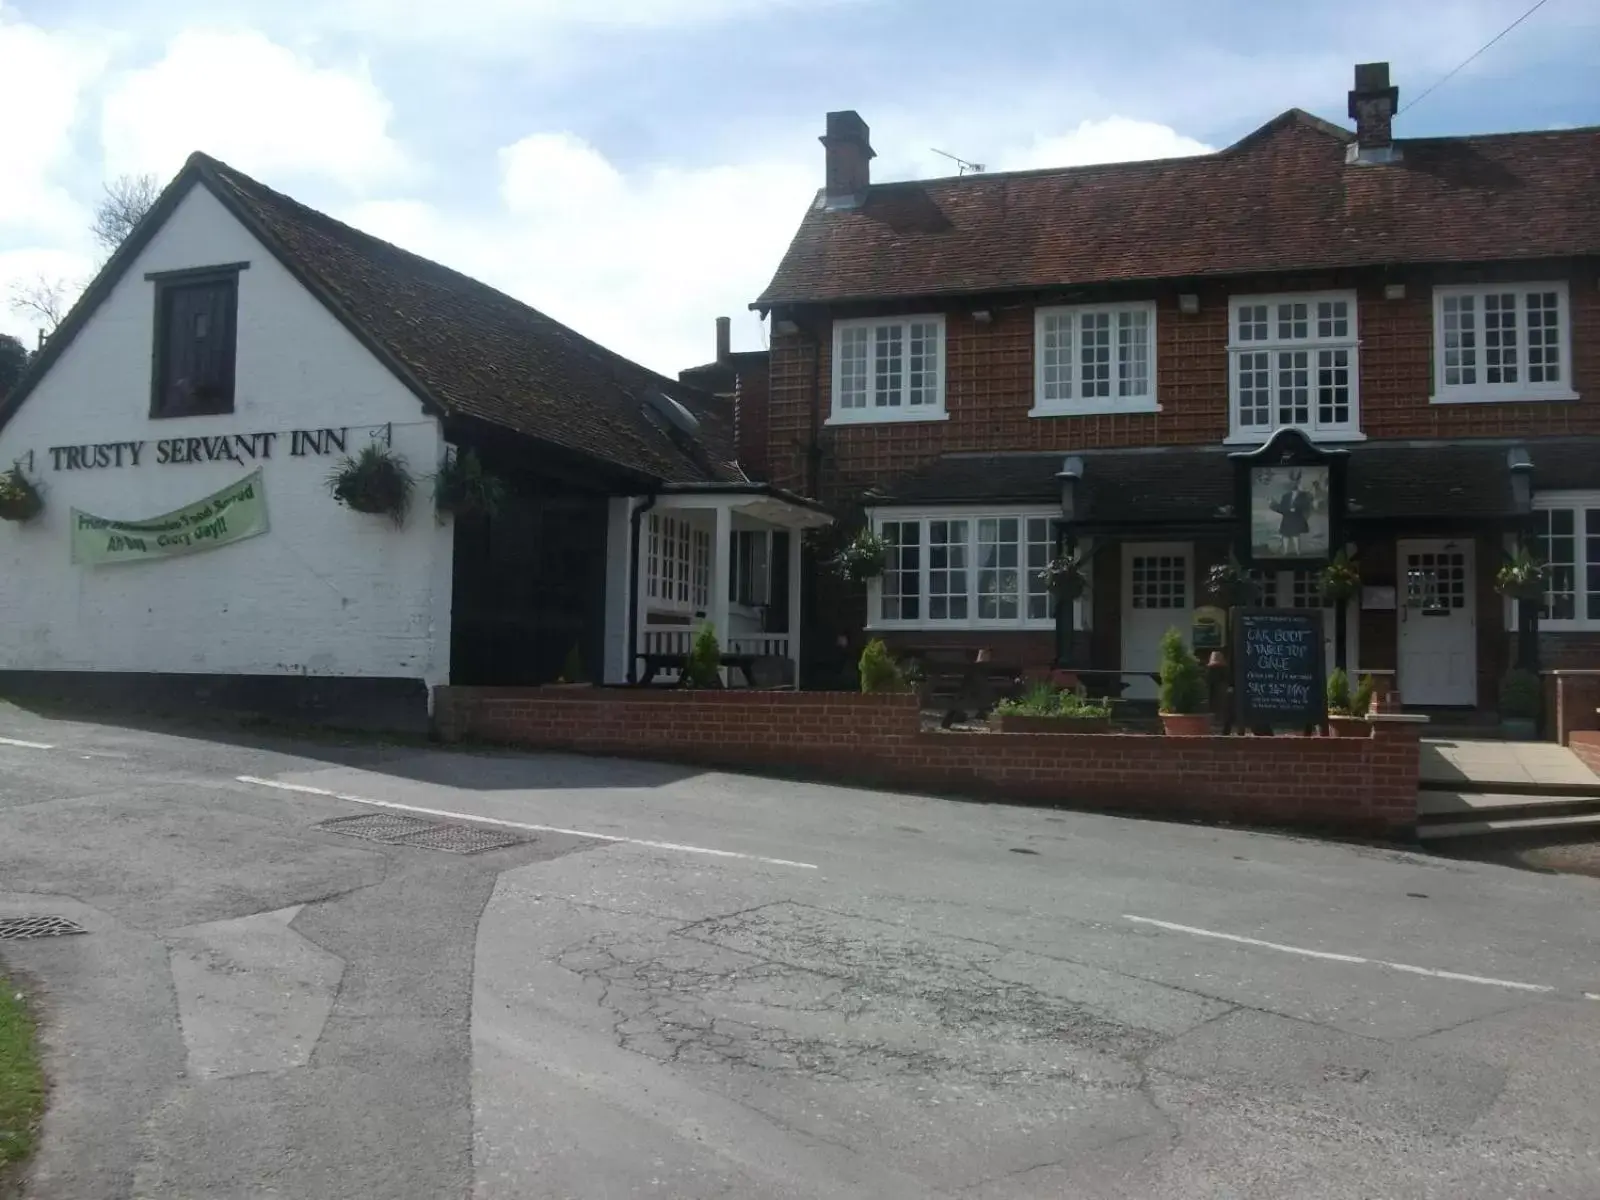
<box><xmin>757</xmin><ymin>64</ymin><xmax>1600</xmax><ymax>709</ymax></box>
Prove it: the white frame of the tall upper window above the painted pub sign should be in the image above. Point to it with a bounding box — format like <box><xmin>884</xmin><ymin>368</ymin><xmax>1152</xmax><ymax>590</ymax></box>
<box><xmin>1226</xmin><ymin>290</ymin><xmax>1366</xmax><ymax>446</ymax></box>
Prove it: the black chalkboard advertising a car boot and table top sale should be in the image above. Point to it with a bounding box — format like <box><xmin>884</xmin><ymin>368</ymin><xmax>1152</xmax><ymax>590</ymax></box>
<box><xmin>1234</xmin><ymin>608</ymin><xmax>1328</xmax><ymax>728</ymax></box>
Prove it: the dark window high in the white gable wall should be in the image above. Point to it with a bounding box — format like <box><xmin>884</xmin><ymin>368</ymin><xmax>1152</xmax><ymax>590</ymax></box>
<box><xmin>150</xmin><ymin>269</ymin><xmax>238</xmax><ymax>418</ymax></box>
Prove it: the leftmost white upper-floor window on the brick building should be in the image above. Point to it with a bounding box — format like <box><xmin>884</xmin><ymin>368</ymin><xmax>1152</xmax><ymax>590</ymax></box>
<box><xmin>829</xmin><ymin>314</ymin><xmax>944</xmax><ymax>424</ymax></box>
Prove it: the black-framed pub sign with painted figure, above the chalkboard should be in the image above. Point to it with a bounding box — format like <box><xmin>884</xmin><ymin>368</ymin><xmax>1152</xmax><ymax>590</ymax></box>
<box><xmin>1229</xmin><ymin>427</ymin><xmax>1350</xmax><ymax>570</ymax></box>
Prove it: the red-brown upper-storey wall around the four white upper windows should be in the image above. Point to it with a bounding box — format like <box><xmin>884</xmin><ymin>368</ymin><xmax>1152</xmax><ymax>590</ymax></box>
<box><xmin>768</xmin><ymin>262</ymin><xmax>1600</xmax><ymax>502</ymax></box>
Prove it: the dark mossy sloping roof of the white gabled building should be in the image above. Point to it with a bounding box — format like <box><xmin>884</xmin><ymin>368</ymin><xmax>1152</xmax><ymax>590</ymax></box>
<box><xmin>190</xmin><ymin>154</ymin><xmax>744</xmax><ymax>483</ymax></box>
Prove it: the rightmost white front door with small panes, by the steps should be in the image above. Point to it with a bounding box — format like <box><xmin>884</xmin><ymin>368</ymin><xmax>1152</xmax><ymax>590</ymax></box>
<box><xmin>1398</xmin><ymin>538</ymin><xmax>1478</xmax><ymax>706</ymax></box>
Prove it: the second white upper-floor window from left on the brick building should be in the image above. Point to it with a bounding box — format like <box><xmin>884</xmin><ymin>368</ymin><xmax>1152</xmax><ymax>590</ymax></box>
<box><xmin>1032</xmin><ymin>301</ymin><xmax>1158</xmax><ymax>416</ymax></box>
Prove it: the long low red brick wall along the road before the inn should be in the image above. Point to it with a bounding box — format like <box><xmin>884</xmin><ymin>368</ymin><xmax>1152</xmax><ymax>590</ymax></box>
<box><xmin>435</xmin><ymin>688</ymin><xmax>1418</xmax><ymax>834</ymax></box>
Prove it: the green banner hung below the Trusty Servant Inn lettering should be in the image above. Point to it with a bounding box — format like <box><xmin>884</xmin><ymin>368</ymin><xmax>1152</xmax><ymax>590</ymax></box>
<box><xmin>72</xmin><ymin>469</ymin><xmax>267</xmax><ymax>566</ymax></box>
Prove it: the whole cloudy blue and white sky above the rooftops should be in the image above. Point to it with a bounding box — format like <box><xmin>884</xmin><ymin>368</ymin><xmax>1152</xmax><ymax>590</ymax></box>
<box><xmin>0</xmin><ymin>0</ymin><xmax>1600</xmax><ymax>373</ymax></box>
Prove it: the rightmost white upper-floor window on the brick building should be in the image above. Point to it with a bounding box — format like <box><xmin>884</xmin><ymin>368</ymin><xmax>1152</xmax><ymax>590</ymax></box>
<box><xmin>1434</xmin><ymin>282</ymin><xmax>1578</xmax><ymax>403</ymax></box>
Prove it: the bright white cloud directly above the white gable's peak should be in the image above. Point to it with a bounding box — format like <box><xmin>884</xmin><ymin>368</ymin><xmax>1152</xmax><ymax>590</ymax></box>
<box><xmin>102</xmin><ymin>30</ymin><xmax>406</xmax><ymax>190</ymax></box>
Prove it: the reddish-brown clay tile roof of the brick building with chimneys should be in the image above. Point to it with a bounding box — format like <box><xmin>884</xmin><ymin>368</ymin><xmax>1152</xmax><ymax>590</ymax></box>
<box><xmin>754</xmin><ymin>109</ymin><xmax>1600</xmax><ymax>309</ymax></box>
